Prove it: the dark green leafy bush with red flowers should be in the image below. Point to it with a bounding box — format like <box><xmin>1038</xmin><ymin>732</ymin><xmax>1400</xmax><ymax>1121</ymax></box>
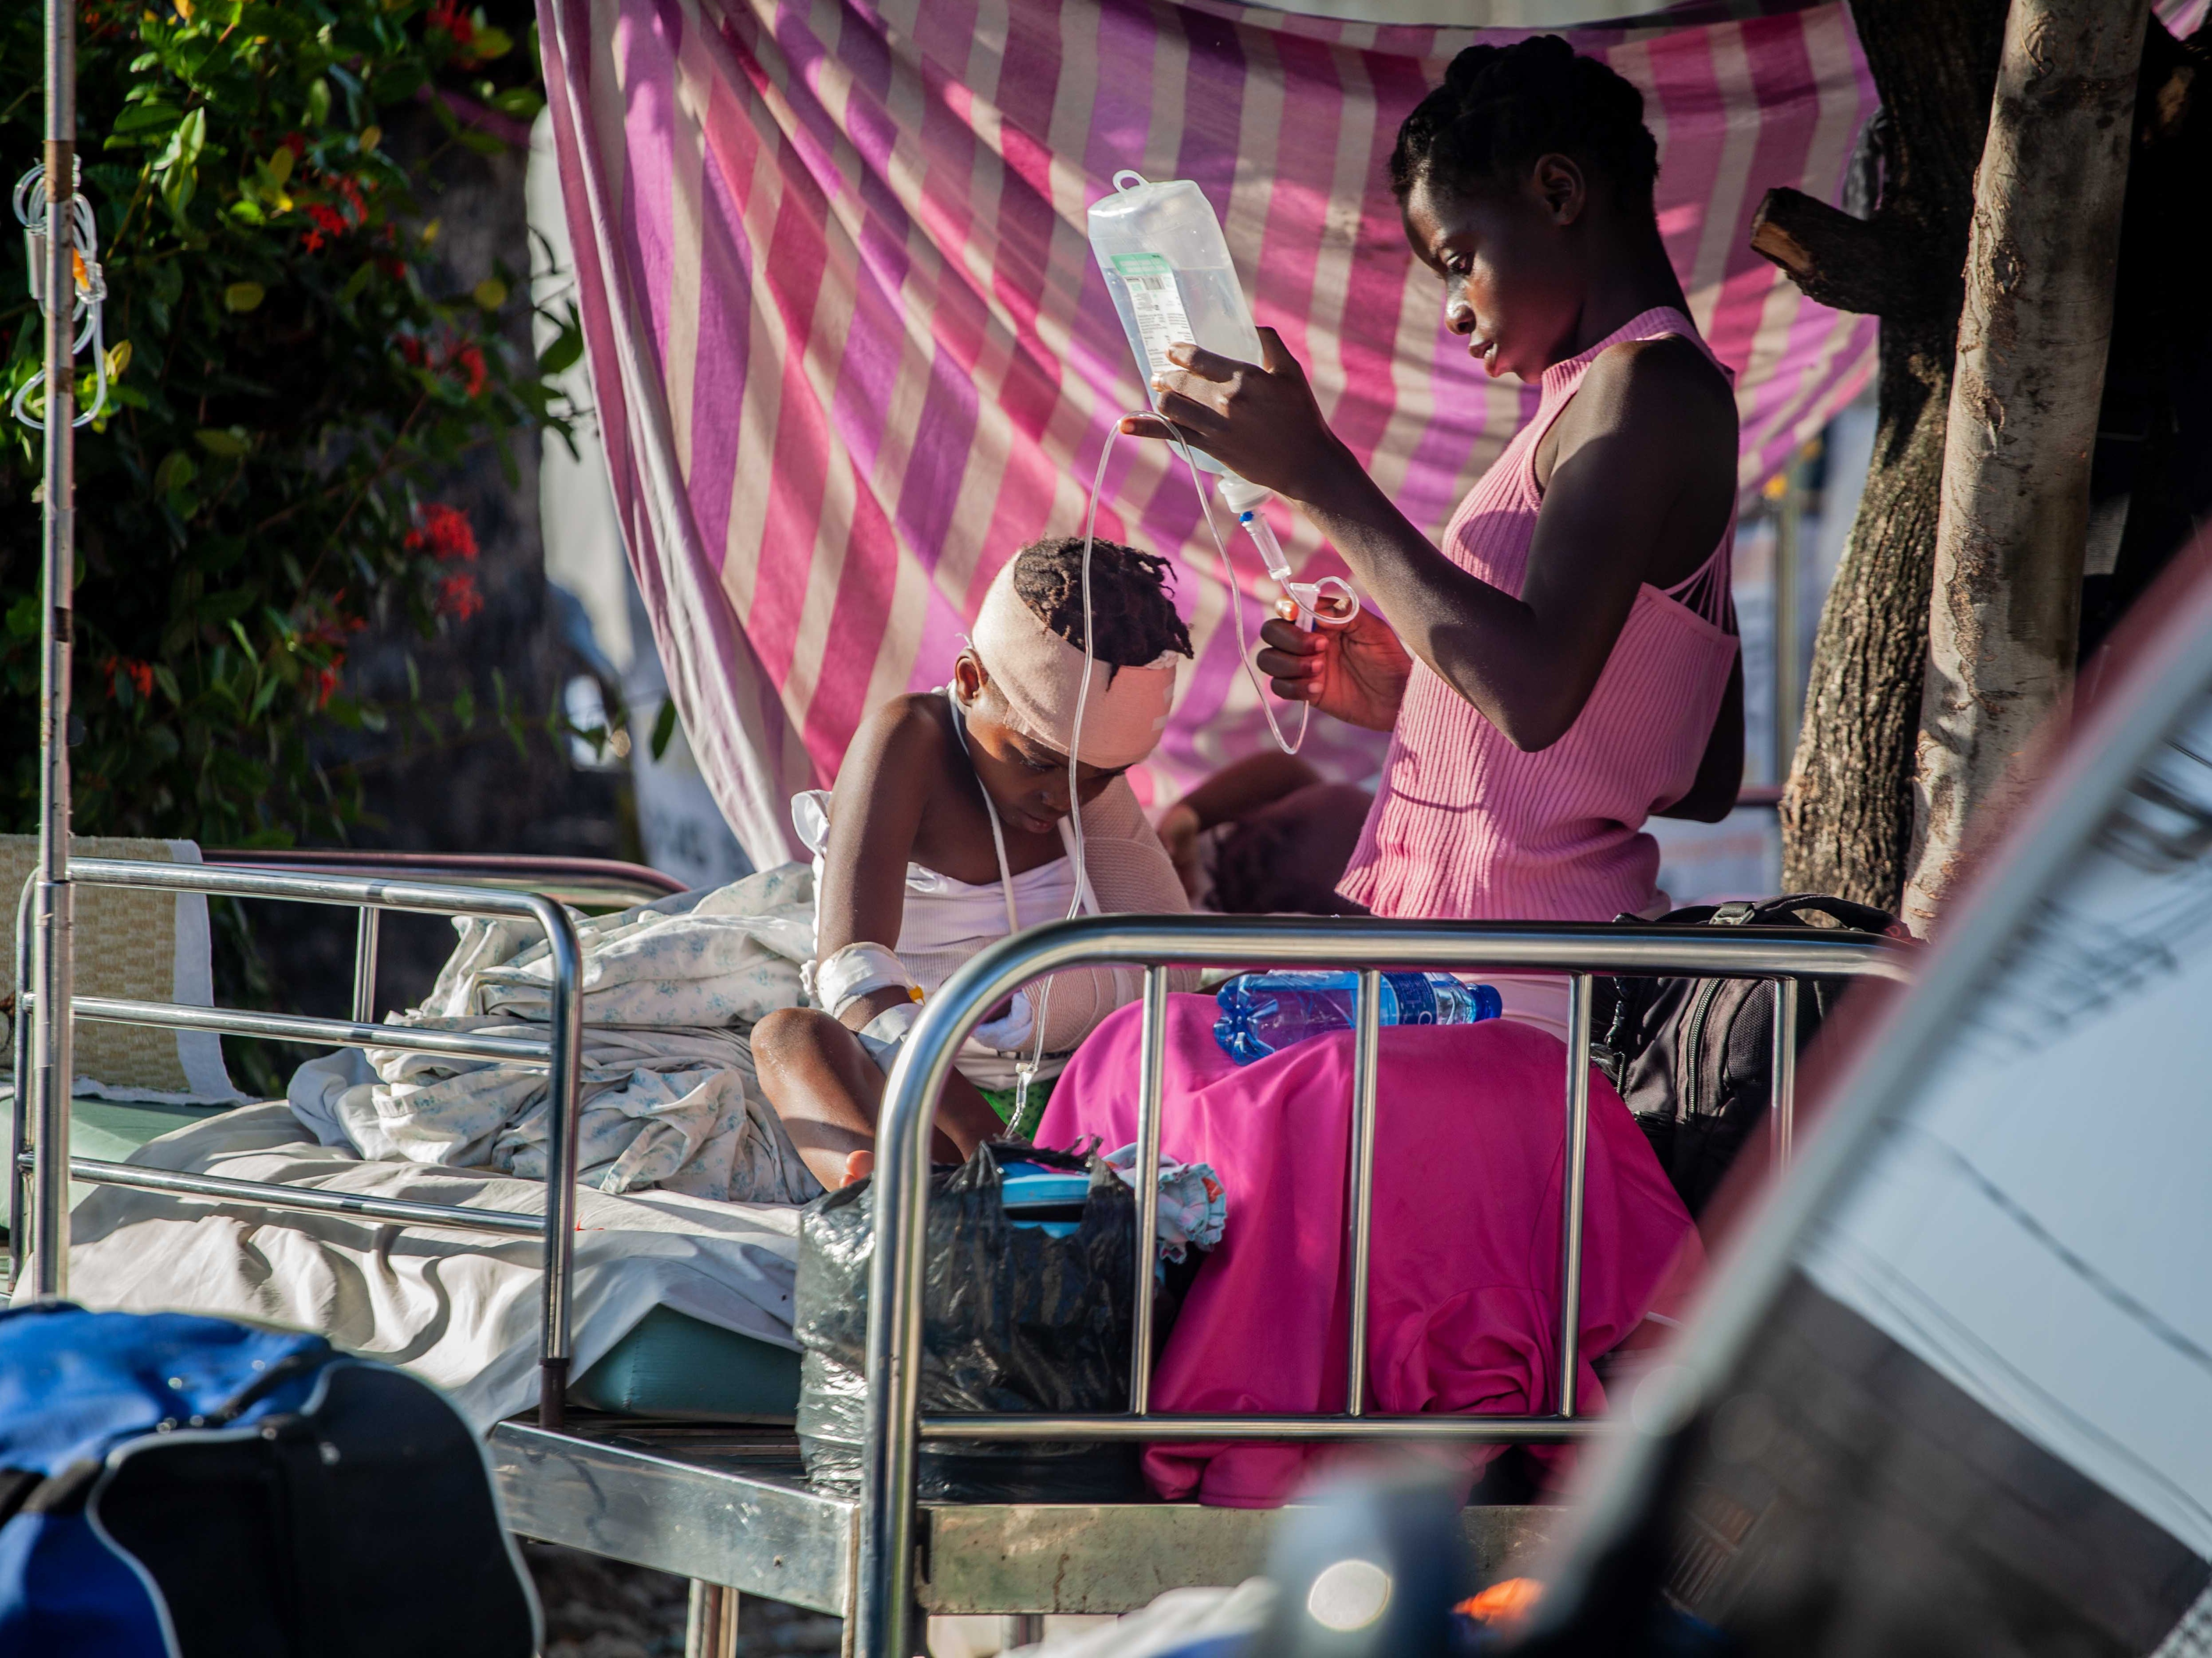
<box><xmin>0</xmin><ymin>0</ymin><xmax>582</xmax><ymax>844</ymax></box>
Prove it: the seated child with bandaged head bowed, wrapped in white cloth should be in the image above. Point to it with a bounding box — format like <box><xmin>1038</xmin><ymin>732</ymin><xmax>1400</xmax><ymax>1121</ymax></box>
<box><xmin>752</xmin><ymin>537</ymin><xmax>1197</xmax><ymax>1187</ymax></box>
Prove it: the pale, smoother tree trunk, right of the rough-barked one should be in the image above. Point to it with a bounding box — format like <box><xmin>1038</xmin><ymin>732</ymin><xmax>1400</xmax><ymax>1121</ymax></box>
<box><xmin>1902</xmin><ymin>0</ymin><xmax>2150</xmax><ymax>935</ymax></box>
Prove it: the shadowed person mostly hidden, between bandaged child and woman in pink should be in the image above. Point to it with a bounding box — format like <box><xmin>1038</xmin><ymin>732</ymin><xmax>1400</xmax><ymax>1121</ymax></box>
<box><xmin>1159</xmin><ymin>749</ymin><xmax>1374</xmax><ymax>915</ymax></box>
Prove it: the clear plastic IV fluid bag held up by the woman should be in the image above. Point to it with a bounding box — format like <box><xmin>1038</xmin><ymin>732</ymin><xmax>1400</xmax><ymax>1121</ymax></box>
<box><xmin>1091</xmin><ymin>173</ymin><xmax>1258</xmax><ymax>473</ymax></box>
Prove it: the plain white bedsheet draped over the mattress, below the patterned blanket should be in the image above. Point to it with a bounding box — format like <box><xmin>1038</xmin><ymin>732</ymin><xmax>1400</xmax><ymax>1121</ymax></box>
<box><xmin>56</xmin><ymin>1101</ymin><xmax>799</xmax><ymax>1430</ymax></box>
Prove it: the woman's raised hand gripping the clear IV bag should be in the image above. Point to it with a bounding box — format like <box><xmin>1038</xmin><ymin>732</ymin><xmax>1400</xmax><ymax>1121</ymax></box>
<box><xmin>1121</xmin><ymin>327</ymin><xmax>1358</xmax><ymax>502</ymax></box>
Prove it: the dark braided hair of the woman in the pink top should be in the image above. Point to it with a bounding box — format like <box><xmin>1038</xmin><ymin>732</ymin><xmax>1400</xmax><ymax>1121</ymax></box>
<box><xmin>1389</xmin><ymin>35</ymin><xmax>1659</xmax><ymax>212</ymax></box>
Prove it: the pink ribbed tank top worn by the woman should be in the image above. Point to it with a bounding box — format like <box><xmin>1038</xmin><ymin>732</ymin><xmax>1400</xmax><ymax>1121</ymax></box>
<box><xmin>1338</xmin><ymin>307</ymin><xmax>1736</xmax><ymax>922</ymax></box>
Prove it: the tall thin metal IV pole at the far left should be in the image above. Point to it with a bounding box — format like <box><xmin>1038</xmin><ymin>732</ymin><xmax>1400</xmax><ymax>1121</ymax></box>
<box><xmin>30</xmin><ymin>0</ymin><xmax>77</xmax><ymax>1300</ymax></box>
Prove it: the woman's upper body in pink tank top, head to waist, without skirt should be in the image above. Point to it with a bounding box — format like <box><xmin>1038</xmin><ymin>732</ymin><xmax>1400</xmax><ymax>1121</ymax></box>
<box><xmin>1126</xmin><ymin>35</ymin><xmax>1743</xmax><ymax>937</ymax></box>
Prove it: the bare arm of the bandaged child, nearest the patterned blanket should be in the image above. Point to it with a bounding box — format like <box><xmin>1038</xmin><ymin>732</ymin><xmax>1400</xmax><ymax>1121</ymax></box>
<box><xmin>814</xmin><ymin>701</ymin><xmax>945</xmax><ymax>1030</ymax></box>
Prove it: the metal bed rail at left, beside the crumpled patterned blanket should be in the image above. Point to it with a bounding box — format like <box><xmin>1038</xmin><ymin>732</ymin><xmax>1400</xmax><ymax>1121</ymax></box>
<box><xmin>7</xmin><ymin>858</ymin><xmax>584</xmax><ymax>1430</ymax></box>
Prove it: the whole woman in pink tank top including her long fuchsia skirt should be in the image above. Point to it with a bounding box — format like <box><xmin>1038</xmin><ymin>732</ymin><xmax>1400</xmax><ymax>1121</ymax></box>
<box><xmin>1037</xmin><ymin>38</ymin><xmax>1707</xmax><ymax>1503</ymax></box>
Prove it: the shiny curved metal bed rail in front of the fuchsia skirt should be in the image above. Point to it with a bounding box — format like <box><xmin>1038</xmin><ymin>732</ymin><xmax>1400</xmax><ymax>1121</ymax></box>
<box><xmin>852</xmin><ymin>915</ymin><xmax>1911</xmax><ymax>1658</ymax></box>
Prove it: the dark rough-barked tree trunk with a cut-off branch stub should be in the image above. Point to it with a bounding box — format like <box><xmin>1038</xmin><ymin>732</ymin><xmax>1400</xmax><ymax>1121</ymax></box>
<box><xmin>1752</xmin><ymin>0</ymin><xmax>2006</xmax><ymax>909</ymax></box>
